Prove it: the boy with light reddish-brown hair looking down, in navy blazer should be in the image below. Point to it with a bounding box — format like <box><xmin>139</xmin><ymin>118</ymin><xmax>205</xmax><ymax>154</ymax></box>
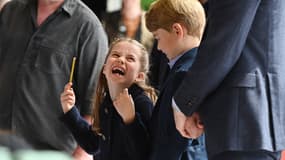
<box><xmin>146</xmin><ymin>0</ymin><xmax>207</xmax><ymax>160</ymax></box>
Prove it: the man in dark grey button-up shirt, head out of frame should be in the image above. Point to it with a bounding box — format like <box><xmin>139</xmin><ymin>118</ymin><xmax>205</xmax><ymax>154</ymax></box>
<box><xmin>0</xmin><ymin>0</ymin><xmax>108</xmax><ymax>160</ymax></box>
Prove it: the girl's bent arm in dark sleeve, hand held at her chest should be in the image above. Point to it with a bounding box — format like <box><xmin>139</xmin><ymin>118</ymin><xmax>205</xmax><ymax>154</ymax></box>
<box><xmin>114</xmin><ymin>95</ymin><xmax>153</xmax><ymax>160</ymax></box>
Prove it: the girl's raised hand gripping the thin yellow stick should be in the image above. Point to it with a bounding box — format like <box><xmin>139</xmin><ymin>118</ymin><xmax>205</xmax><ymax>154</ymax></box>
<box><xmin>60</xmin><ymin>82</ymin><xmax>75</xmax><ymax>113</ymax></box>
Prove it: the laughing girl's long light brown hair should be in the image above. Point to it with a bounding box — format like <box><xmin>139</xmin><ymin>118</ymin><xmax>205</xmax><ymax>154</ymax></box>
<box><xmin>92</xmin><ymin>38</ymin><xmax>157</xmax><ymax>134</ymax></box>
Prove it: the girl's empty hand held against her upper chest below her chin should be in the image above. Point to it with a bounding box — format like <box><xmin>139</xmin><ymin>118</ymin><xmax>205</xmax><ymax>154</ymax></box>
<box><xmin>113</xmin><ymin>88</ymin><xmax>135</xmax><ymax>124</ymax></box>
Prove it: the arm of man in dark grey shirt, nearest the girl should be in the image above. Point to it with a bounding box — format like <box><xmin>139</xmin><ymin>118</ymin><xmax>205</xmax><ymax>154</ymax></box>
<box><xmin>73</xmin><ymin>18</ymin><xmax>108</xmax><ymax>160</ymax></box>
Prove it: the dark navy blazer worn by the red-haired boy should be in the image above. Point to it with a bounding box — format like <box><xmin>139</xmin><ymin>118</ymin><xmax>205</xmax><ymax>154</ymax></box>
<box><xmin>150</xmin><ymin>48</ymin><xmax>206</xmax><ymax>160</ymax></box>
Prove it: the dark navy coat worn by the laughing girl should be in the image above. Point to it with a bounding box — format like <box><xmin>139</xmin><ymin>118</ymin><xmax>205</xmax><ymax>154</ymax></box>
<box><xmin>62</xmin><ymin>85</ymin><xmax>153</xmax><ymax>160</ymax></box>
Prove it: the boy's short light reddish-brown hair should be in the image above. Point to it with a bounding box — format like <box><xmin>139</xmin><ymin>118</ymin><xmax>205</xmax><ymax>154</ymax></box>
<box><xmin>145</xmin><ymin>0</ymin><xmax>206</xmax><ymax>39</ymax></box>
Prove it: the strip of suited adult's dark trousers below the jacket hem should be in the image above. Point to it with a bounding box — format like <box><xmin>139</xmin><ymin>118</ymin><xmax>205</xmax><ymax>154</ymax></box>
<box><xmin>209</xmin><ymin>151</ymin><xmax>281</xmax><ymax>160</ymax></box>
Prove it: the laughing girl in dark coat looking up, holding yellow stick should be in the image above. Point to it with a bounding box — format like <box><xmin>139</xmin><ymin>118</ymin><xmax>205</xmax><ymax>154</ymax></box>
<box><xmin>61</xmin><ymin>38</ymin><xmax>156</xmax><ymax>160</ymax></box>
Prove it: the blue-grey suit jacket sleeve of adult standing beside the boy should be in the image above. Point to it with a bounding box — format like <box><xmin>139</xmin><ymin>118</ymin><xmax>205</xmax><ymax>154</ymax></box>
<box><xmin>174</xmin><ymin>0</ymin><xmax>260</xmax><ymax>115</ymax></box>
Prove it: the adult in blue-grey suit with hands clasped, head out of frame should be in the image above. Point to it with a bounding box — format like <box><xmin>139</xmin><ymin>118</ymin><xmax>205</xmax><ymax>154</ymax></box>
<box><xmin>173</xmin><ymin>0</ymin><xmax>285</xmax><ymax>160</ymax></box>
